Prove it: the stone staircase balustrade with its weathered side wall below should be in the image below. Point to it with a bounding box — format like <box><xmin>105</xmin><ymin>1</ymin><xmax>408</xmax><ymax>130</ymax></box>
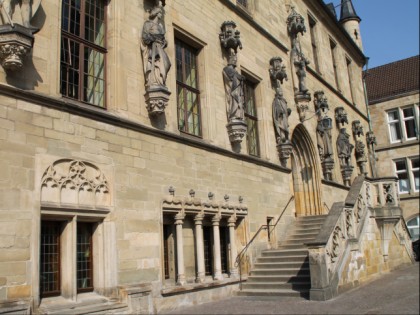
<box><xmin>307</xmin><ymin>176</ymin><xmax>413</xmax><ymax>300</ymax></box>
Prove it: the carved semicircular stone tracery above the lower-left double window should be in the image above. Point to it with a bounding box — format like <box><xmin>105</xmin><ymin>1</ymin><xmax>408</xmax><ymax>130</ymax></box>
<box><xmin>41</xmin><ymin>159</ymin><xmax>111</xmax><ymax>207</ymax></box>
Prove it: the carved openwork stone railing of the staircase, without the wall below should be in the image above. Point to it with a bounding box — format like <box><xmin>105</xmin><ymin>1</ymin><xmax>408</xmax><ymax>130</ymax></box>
<box><xmin>306</xmin><ymin>176</ymin><xmax>414</xmax><ymax>300</ymax></box>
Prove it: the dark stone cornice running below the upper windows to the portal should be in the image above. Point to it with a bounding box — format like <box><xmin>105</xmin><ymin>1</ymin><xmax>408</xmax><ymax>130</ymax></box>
<box><xmin>0</xmin><ymin>84</ymin><xmax>291</xmax><ymax>174</ymax></box>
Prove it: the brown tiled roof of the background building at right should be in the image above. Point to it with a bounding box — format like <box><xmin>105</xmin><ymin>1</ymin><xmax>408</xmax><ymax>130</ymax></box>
<box><xmin>366</xmin><ymin>55</ymin><xmax>420</xmax><ymax>104</ymax></box>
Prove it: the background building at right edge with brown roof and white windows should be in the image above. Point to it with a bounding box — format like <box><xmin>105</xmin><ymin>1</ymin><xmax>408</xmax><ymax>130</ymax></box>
<box><xmin>366</xmin><ymin>55</ymin><xmax>420</xmax><ymax>240</ymax></box>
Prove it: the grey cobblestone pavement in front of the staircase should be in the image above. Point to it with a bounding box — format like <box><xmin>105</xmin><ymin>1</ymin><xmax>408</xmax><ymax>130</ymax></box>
<box><xmin>159</xmin><ymin>262</ymin><xmax>420</xmax><ymax>315</ymax></box>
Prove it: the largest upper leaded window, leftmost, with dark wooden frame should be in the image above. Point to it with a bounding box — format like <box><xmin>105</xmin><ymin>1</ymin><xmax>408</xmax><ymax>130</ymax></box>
<box><xmin>60</xmin><ymin>0</ymin><xmax>106</xmax><ymax>107</ymax></box>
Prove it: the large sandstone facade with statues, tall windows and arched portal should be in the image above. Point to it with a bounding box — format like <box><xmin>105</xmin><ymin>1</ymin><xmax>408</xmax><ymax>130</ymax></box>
<box><xmin>0</xmin><ymin>0</ymin><xmax>410</xmax><ymax>314</ymax></box>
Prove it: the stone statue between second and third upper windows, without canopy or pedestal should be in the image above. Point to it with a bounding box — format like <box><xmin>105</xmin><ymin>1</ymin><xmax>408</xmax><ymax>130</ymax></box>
<box><xmin>223</xmin><ymin>55</ymin><xmax>245</xmax><ymax>121</ymax></box>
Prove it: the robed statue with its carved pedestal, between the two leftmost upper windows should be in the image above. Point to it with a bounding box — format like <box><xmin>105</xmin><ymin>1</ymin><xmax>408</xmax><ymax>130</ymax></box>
<box><xmin>141</xmin><ymin>5</ymin><xmax>171</xmax><ymax>115</ymax></box>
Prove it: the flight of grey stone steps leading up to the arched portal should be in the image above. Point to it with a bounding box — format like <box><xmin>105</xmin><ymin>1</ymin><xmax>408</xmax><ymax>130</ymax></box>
<box><xmin>238</xmin><ymin>215</ymin><xmax>327</xmax><ymax>298</ymax></box>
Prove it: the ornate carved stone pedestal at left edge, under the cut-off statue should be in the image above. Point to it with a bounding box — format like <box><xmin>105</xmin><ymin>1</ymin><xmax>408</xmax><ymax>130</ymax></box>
<box><xmin>0</xmin><ymin>24</ymin><xmax>34</xmax><ymax>71</ymax></box>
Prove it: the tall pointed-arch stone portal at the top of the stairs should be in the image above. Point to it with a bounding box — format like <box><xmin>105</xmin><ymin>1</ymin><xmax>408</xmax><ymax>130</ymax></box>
<box><xmin>291</xmin><ymin>124</ymin><xmax>323</xmax><ymax>216</ymax></box>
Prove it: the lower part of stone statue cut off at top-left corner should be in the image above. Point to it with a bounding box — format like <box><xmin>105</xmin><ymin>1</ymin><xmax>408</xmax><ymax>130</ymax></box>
<box><xmin>0</xmin><ymin>0</ymin><xmax>41</xmax><ymax>31</ymax></box>
